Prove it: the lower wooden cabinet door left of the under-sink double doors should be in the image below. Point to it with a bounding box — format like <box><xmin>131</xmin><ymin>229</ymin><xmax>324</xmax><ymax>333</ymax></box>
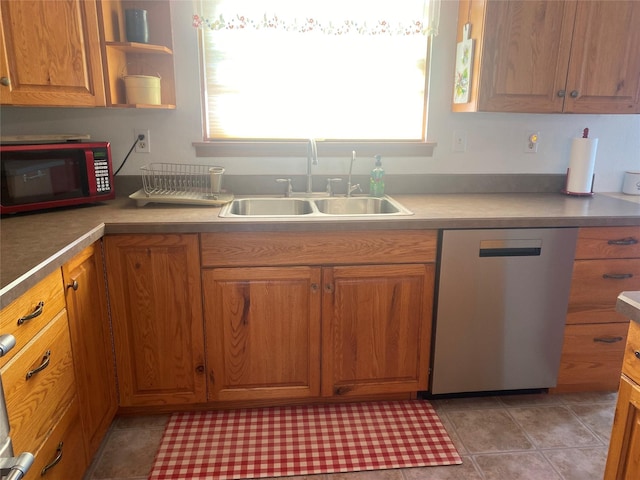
<box><xmin>104</xmin><ymin>234</ymin><xmax>206</xmax><ymax>406</ymax></box>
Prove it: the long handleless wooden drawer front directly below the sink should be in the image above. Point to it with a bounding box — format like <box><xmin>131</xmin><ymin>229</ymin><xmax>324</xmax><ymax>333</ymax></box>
<box><xmin>200</xmin><ymin>230</ymin><xmax>438</xmax><ymax>267</ymax></box>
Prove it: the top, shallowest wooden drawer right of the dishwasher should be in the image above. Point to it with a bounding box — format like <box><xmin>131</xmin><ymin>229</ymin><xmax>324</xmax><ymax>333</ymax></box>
<box><xmin>576</xmin><ymin>227</ymin><xmax>640</xmax><ymax>259</ymax></box>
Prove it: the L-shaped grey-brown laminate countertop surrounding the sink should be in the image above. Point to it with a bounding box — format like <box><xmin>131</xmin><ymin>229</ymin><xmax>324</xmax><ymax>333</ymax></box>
<box><xmin>0</xmin><ymin>193</ymin><xmax>640</xmax><ymax>308</ymax></box>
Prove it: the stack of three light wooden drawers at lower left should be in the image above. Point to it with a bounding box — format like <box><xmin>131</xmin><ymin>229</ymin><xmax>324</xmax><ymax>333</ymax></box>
<box><xmin>0</xmin><ymin>260</ymin><xmax>88</xmax><ymax>480</ymax></box>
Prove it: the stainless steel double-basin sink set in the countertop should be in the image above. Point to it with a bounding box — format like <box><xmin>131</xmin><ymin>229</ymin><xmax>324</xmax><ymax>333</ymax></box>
<box><xmin>219</xmin><ymin>196</ymin><xmax>413</xmax><ymax>218</ymax></box>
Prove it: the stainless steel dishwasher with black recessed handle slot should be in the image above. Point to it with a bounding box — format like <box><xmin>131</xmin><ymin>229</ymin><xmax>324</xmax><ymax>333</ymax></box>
<box><xmin>431</xmin><ymin>228</ymin><xmax>578</xmax><ymax>394</ymax></box>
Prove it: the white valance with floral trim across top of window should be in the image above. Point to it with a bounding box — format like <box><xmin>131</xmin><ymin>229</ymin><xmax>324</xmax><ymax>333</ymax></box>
<box><xmin>193</xmin><ymin>0</ymin><xmax>440</xmax><ymax>35</ymax></box>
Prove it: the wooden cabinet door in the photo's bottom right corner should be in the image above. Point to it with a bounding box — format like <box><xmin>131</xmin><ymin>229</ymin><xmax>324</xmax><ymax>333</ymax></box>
<box><xmin>604</xmin><ymin>375</ymin><xmax>640</xmax><ymax>480</ymax></box>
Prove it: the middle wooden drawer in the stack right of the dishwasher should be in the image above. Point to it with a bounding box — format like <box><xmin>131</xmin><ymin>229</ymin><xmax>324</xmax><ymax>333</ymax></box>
<box><xmin>567</xmin><ymin>259</ymin><xmax>640</xmax><ymax>324</ymax></box>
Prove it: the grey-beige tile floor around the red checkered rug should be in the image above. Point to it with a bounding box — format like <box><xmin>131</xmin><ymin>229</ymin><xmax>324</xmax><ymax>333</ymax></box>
<box><xmin>85</xmin><ymin>392</ymin><xmax>616</xmax><ymax>480</ymax></box>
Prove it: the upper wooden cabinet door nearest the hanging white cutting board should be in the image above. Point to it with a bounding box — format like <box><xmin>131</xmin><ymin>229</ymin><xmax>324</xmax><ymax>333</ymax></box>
<box><xmin>476</xmin><ymin>0</ymin><xmax>576</xmax><ymax>113</ymax></box>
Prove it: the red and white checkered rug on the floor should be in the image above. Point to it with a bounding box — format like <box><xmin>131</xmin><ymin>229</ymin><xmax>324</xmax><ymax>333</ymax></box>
<box><xmin>149</xmin><ymin>400</ymin><xmax>462</xmax><ymax>480</ymax></box>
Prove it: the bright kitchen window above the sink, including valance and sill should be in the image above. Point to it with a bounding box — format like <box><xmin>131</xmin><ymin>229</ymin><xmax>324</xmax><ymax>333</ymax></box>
<box><xmin>193</xmin><ymin>0</ymin><xmax>440</xmax><ymax>156</ymax></box>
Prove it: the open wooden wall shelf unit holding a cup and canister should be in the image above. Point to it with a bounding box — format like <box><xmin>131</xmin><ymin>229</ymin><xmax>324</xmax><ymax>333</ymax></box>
<box><xmin>98</xmin><ymin>0</ymin><xmax>176</xmax><ymax>109</ymax></box>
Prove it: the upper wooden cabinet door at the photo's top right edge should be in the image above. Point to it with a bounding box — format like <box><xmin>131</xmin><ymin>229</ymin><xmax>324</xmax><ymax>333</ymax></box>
<box><xmin>564</xmin><ymin>0</ymin><xmax>640</xmax><ymax>113</ymax></box>
